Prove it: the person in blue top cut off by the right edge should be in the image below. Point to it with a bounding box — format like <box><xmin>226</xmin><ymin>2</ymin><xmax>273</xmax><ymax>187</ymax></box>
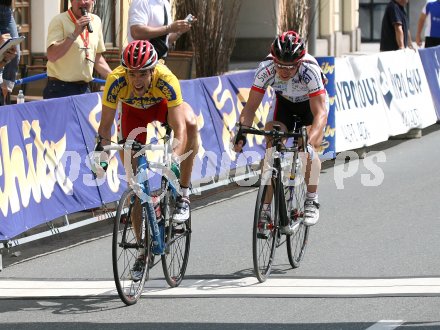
<box><xmin>416</xmin><ymin>0</ymin><xmax>440</xmax><ymax>48</ymax></box>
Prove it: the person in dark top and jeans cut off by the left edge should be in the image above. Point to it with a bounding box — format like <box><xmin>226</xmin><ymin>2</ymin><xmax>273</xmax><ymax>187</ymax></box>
<box><xmin>0</xmin><ymin>0</ymin><xmax>20</xmax><ymax>105</ymax></box>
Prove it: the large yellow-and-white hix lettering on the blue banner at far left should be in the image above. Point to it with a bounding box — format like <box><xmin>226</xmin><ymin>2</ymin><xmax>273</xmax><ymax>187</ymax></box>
<box><xmin>0</xmin><ymin>120</ymin><xmax>73</xmax><ymax>217</ymax></box>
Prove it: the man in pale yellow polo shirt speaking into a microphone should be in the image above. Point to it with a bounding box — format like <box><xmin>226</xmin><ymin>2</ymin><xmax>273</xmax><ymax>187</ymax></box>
<box><xmin>43</xmin><ymin>0</ymin><xmax>111</xmax><ymax>99</ymax></box>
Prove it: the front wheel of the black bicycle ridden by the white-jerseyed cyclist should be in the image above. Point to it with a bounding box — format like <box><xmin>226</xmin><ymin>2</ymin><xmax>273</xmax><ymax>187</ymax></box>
<box><xmin>252</xmin><ymin>174</ymin><xmax>279</xmax><ymax>282</ymax></box>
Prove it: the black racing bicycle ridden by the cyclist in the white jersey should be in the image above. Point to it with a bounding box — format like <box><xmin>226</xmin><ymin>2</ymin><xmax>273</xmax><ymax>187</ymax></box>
<box><xmin>237</xmin><ymin>124</ymin><xmax>310</xmax><ymax>282</ymax></box>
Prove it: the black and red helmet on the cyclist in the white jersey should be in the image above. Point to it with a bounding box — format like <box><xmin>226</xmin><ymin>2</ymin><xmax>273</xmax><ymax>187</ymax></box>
<box><xmin>270</xmin><ymin>31</ymin><xmax>306</xmax><ymax>62</ymax></box>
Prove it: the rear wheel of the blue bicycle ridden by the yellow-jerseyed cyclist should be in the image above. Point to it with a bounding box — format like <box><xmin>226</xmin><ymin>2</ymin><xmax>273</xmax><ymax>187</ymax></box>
<box><xmin>161</xmin><ymin>178</ymin><xmax>191</xmax><ymax>287</ymax></box>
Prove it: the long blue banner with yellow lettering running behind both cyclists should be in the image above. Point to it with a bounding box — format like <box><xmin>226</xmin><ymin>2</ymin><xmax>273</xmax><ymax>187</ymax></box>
<box><xmin>0</xmin><ymin>67</ymin><xmax>334</xmax><ymax>241</ymax></box>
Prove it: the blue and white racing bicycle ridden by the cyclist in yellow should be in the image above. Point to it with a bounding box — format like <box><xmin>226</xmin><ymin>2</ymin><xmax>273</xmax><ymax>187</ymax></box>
<box><xmin>99</xmin><ymin>126</ymin><xmax>191</xmax><ymax>305</ymax></box>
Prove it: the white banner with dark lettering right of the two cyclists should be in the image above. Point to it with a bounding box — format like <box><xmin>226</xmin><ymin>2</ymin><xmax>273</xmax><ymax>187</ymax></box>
<box><xmin>335</xmin><ymin>50</ymin><xmax>437</xmax><ymax>152</ymax></box>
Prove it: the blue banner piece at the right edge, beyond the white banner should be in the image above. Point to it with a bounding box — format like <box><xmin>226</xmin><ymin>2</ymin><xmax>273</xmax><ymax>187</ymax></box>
<box><xmin>419</xmin><ymin>46</ymin><xmax>440</xmax><ymax>120</ymax></box>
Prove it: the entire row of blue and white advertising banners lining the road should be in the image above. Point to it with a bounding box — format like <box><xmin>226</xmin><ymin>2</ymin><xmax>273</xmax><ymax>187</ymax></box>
<box><xmin>0</xmin><ymin>50</ymin><xmax>439</xmax><ymax>241</ymax></box>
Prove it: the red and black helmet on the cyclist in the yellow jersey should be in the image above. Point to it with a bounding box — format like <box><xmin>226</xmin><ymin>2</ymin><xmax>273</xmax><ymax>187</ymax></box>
<box><xmin>121</xmin><ymin>40</ymin><xmax>158</xmax><ymax>70</ymax></box>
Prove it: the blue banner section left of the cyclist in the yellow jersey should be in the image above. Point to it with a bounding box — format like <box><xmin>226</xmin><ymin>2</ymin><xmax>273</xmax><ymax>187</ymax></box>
<box><xmin>0</xmin><ymin>94</ymin><xmax>126</xmax><ymax>240</ymax></box>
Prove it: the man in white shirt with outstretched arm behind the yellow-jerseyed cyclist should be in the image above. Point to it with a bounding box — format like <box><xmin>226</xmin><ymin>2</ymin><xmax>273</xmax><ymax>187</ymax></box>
<box><xmin>127</xmin><ymin>0</ymin><xmax>196</xmax><ymax>57</ymax></box>
